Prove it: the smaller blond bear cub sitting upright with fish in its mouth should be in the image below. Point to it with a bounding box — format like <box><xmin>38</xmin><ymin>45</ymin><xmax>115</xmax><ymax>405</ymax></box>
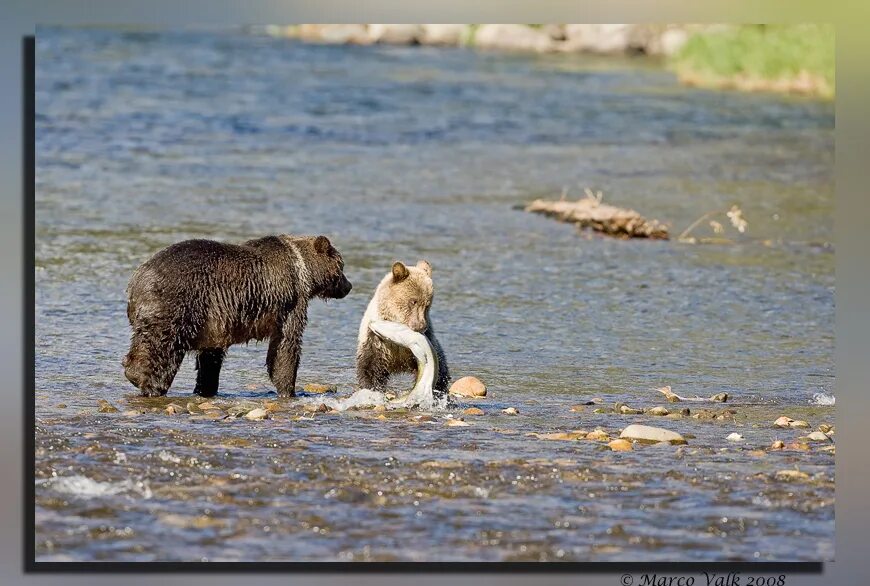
<box><xmin>356</xmin><ymin>260</ymin><xmax>450</xmax><ymax>393</ymax></box>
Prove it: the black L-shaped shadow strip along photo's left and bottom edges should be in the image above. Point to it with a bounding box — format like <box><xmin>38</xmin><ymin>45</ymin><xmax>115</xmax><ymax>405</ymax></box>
<box><xmin>22</xmin><ymin>30</ymin><xmax>824</xmax><ymax>575</ymax></box>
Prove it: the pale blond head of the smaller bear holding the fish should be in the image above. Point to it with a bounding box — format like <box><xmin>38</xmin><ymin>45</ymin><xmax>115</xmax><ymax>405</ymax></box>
<box><xmin>378</xmin><ymin>260</ymin><xmax>434</xmax><ymax>333</ymax></box>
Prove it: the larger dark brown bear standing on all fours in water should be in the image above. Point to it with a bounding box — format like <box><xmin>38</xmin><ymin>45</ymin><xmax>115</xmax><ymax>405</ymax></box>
<box><xmin>123</xmin><ymin>235</ymin><xmax>351</xmax><ymax>397</ymax></box>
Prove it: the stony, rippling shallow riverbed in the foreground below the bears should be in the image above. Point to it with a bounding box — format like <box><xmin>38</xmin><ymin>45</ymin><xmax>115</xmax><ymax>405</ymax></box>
<box><xmin>36</xmin><ymin>392</ymin><xmax>835</xmax><ymax>561</ymax></box>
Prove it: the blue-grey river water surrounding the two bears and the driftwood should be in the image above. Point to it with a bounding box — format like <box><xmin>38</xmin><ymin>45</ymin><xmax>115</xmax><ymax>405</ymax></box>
<box><xmin>36</xmin><ymin>29</ymin><xmax>835</xmax><ymax>561</ymax></box>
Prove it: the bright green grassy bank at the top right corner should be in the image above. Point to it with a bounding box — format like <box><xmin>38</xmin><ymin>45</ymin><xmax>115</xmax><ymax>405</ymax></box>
<box><xmin>672</xmin><ymin>24</ymin><xmax>835</xmax><ymax>99</ymax></box>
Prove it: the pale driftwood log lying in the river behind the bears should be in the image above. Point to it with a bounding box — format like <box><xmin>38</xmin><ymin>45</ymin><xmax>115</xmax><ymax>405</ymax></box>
<box><xmin>524</xmin><ymin>195</ymin><xmax>668</xmax><ymax>240</ymax></box>
